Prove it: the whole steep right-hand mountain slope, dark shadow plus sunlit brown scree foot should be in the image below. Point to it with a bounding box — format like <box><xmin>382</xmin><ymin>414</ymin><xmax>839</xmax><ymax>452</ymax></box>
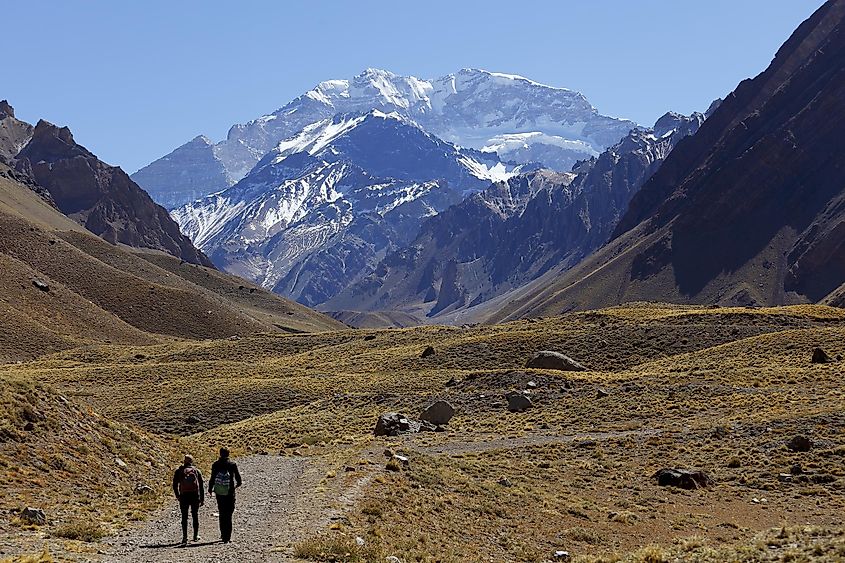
<box><xmin>491</xmin><ymin>0</ymin><xmax>845</xmax><ymax>319</ymax></box>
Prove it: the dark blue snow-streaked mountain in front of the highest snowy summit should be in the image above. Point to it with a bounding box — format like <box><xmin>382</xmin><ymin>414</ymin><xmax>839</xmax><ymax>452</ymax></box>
<box><xmin>173</xmin><ymin>110</ymin><xmax>513</xmax><ymax>306</ymax></box>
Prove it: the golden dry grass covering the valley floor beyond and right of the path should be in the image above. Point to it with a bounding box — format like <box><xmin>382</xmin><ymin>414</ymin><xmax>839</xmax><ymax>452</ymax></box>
<box><xmin>2</xmin><ymin>304</ymin><xmax>845</xmax><ymax>561</ymax></box>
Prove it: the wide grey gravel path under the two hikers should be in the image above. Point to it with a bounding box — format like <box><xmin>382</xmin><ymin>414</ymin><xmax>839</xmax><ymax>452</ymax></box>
<box><xmin>103</xmin><ymin>455</ymin><xmax>354</xmax><ymax>563</ymax></box>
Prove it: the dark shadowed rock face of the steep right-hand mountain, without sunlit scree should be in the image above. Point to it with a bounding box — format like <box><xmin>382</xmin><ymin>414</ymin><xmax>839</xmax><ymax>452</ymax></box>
<box><xmin>617</xmin><ymin>1</ymin><xmax>845</xmax><ymax>304</ymax></box>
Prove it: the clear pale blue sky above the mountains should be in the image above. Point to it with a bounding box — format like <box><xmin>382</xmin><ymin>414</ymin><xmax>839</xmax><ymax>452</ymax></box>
<box><xmin>0</xmin><ymin>0</ymin><xmax>823</xmax><ymax>172</ymax></box>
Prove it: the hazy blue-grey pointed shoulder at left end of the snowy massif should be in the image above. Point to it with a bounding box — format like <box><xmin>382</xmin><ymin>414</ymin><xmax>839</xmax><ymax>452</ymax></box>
<box><xmin>132</xmin><ymin>135</ymin><xmax>234</xmax><ymax>209</ymax></box>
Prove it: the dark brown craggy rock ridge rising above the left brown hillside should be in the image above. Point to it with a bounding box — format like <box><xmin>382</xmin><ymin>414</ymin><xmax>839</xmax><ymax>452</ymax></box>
<box><xmin>17</xmin><ymin>120</ymin><xmax>211</xmax><ymax>266</ymax></box>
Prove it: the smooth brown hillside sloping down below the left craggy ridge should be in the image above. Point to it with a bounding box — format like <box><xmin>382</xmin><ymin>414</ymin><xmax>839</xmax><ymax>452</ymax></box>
<box><xmin>0</xmin><ymin>170</ymin><xmax>343</xmax><ymax>361</ymax></box>
